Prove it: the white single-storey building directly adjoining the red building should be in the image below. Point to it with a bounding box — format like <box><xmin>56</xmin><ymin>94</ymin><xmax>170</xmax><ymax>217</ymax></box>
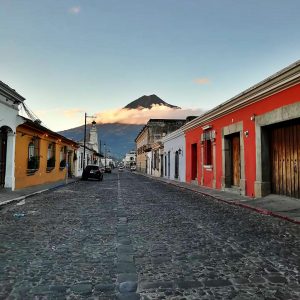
<box><xmin>162</xmin><ymin>128</ymin><xmax>186</xmax><ymax>182</ymax></box>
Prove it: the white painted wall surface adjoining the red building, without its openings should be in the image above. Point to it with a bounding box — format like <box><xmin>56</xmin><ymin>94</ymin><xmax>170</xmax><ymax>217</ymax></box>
<box><xmin>163</xmin><ymin>132</ymin><xmax>186</xmax><ymax>182</ymax></box>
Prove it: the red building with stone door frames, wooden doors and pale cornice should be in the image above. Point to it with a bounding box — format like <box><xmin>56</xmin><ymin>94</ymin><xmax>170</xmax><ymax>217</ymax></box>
<box><xmin>183</xmin><ymin>60</ymin><xmax>300</xmax><ymax>198</ymax></box>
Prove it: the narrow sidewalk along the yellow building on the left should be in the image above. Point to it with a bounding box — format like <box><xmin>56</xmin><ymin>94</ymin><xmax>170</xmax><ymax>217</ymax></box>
<box><xmin>0</xmin><ymin>178</ymin><xmax>79</xmax><ymax>207</ymax></box>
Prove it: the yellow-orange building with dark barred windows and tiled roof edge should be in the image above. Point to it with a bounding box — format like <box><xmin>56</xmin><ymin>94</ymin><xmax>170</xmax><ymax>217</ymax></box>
<box><xmin>15</xmin><ymin>118</ymin><xmax>78</xmax><ymax>189</ymax></box>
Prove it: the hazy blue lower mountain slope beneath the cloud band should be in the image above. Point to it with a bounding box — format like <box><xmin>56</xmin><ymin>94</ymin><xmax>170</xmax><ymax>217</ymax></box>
<box><xmin>59</xmin><ymin>123</ymin><xmax>144</xmax><ymax>158</ymax></box>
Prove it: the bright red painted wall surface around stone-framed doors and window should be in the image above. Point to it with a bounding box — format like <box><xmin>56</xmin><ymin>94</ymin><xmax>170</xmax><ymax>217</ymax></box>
<box><xmin>185</xmin><ymin>84</ymin><xmax>300</xmax><ymax>197</ymax></box>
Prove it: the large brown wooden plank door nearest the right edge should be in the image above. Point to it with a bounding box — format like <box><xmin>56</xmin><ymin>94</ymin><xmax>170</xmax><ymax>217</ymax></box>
<box><xmin>270</xmin><ymin>121</ymin><xmax>300</xmax><ymax>198</ymax></box>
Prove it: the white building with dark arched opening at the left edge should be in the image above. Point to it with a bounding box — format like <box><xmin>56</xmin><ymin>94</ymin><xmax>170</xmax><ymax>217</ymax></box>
<box><xmin>0</xmin><ymin>81</ymin><xmax>25</xmax><ymax>190</ymax></box>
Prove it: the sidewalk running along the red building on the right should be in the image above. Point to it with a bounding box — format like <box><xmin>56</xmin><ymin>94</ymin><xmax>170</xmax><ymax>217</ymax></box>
<box><xmin>136</xmin><ymin>172</ymin><xmax>300</xmax><ymax>224</ymax></box>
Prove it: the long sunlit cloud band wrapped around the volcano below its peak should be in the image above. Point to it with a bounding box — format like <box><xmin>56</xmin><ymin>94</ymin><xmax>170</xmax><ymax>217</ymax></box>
<box><xmin>95</xmin><ymin>105</ymin><xmax>204</xmax><ymax>124</ymax></box>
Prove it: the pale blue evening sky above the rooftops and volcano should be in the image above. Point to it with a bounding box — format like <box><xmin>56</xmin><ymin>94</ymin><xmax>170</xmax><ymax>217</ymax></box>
<box><xmin>0</xmin><ymin>0</ymin><xmax>300</xmax><ymax>130</ymax></box>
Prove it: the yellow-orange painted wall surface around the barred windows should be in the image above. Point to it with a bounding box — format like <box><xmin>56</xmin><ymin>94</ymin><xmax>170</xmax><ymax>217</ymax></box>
<box><xmin>15</xmin><ymin>125</ymin><xmax>75</xmax><ymax>189</ymax></box>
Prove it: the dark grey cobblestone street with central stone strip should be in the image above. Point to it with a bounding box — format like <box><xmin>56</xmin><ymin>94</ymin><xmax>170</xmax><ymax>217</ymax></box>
<box><xmin>0</xmin><ymin>172</ymin><xmax>300</xmax><ymax>300</ymax></box>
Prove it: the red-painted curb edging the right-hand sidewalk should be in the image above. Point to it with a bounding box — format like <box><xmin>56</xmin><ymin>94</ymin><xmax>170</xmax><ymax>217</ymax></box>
<box><xmin>135</xmin><ymin>173</ymin><xmax>300</xmax><ymax>225</ymax></box>
